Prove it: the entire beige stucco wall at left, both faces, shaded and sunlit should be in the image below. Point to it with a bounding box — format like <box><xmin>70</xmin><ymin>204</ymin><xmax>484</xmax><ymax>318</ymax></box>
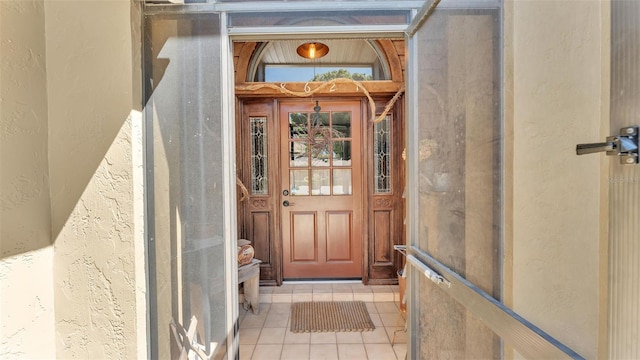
<box><xmin>0</xmin><ymin>0</ymin><xmax>147</xmax><ymax>359</ymax></box>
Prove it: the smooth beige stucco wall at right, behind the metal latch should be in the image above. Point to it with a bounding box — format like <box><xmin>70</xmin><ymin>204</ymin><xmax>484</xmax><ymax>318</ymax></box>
<box><xmin>505</xmin><ymin>0</ymin><xmax>608</xmax><ymax>358</ymax></box>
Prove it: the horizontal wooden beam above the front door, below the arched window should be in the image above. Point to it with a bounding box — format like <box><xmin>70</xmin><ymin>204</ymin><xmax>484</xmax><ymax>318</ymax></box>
<box><xmin>235</xmin><ymin>80</ymin><xmax>404</xmax><ymax>98</ymax></box>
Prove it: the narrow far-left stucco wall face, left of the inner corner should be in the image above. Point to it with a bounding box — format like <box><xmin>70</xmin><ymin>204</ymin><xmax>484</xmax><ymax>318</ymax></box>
<box><xmin>0</xmin><ymin>1</ymin><xmax>55</xmax><ymax>360</ymax></box>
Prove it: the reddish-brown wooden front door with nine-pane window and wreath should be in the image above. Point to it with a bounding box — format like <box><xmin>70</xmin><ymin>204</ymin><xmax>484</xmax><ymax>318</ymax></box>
<box><xmin>279</xmin><ymin>101</ymin><xmax>363</xmax><ymax>279</ymax></box>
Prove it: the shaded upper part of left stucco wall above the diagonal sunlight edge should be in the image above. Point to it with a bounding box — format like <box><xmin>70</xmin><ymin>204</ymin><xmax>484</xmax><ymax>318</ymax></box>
<box><xmin>0</xmin><ymin>1</ymin><xmax>142</xmax><ymax>258</ymax></box>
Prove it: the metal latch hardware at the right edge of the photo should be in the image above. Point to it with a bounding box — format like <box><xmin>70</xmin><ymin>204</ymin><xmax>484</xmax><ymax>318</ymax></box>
<box><xmin>576</xmin><ymin>126</ymin><xmax>638</xmax><ymax>165</ymax></box>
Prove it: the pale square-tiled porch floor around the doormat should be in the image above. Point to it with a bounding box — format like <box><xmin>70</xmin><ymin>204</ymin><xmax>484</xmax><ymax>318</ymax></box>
<box><xmin>240</xmin><ymin>283</ymin><xmax>407</xmax><ymax>360</ymax></box>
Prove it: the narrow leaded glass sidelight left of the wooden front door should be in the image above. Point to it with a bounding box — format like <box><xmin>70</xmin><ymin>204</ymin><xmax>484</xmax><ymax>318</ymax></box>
<box><xmin>249</xmin><ymin>116</ymin><xmax>269</xmax><ymax>195</ymax></box>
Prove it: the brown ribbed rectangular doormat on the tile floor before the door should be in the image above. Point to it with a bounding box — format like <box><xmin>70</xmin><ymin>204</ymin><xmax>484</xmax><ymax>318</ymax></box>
<box><xmin>291</xmin><ymin>301</ymin><xmax>376</xmax><ymax>333</ymax></box>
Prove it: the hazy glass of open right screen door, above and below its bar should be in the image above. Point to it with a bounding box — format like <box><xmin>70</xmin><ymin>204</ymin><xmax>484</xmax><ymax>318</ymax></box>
<box><xmin>408</xmin><ymin>8</ymin><xmax>502</xmax><ymax>359</ymax></box>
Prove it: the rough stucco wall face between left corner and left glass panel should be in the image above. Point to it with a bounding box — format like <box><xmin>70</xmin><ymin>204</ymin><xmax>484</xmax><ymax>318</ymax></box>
<box><xmin>45</xmin><ymin>0</ymin><xmax>145</xmax><ymax>359</ymax></box>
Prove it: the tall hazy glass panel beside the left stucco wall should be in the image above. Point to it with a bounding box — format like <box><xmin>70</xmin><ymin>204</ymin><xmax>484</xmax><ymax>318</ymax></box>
<box><xmin>143</xmin><ymin>13</ymin><xmax>234</xmax><ymax>359</ymax></box>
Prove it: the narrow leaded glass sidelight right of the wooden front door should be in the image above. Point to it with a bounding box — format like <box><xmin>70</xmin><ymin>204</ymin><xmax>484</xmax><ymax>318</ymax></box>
<box><xmin>373</xmin><ymin>115</ymin><xmax>391</xmax><ymax>194</ymax></box>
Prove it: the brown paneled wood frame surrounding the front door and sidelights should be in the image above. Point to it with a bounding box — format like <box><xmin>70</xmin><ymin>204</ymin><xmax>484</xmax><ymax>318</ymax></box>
<box><xmin>236</xmin><ymin>95</ymin><xmax>405</xmax><ymax>285</ymax></box>
